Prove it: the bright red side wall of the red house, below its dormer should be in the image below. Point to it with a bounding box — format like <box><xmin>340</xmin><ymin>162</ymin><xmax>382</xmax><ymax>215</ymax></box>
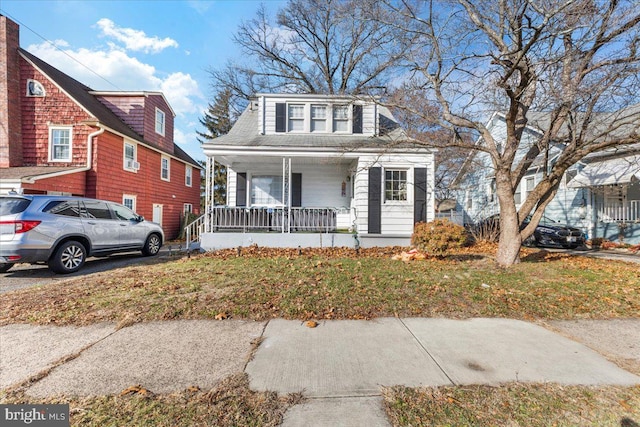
<box><xmin>88</xmin><ymin>132</ymin><xmax>200</xmax><ymax>239</ymax></box>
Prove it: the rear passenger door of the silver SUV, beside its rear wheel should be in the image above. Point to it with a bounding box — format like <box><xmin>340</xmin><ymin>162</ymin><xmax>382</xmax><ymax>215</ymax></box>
<box><xmin>80</xmin><ymin>200</ymin><xmax>120</xmax><ymax>251</ymax></box>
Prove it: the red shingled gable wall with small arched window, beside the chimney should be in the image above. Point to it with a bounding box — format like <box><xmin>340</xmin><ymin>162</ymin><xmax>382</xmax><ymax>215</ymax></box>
<box><xmin>20</xmin><ymin>57</ymin><xmax>95</xmax><ymax>166</ymax></box>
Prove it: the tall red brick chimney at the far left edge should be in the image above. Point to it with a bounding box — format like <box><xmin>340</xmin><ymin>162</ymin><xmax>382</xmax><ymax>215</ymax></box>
<box><xmin>0</xmin><ymin>15</ymin><xmax>23</xmax><ymax>167</ymax></box>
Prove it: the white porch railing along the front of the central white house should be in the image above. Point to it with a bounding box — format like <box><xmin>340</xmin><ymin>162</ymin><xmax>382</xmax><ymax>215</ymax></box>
<box><xmin>204</xmin><ymin>206</ymin><xmax>351</xmax><ymax>233</ymax></box>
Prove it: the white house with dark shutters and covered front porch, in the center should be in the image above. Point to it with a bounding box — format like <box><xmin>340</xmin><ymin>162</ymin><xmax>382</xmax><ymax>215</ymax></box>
<box><xmin>196</xmin><ymin>94</ymin><xmax>434</xmax><ymax>250</ymax></box>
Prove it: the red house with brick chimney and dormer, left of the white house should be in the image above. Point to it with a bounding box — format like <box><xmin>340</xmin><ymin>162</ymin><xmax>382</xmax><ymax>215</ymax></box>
<box><xmin>0</xmin><ymin>15</ymin><xmax>201</xmax><ymax>239</ymax></box>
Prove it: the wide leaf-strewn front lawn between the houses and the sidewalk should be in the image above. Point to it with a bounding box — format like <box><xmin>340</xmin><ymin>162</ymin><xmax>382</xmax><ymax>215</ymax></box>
<box><xmin>0</xmin><ymin>247</ymin><xmax>640</xmax><ymax>325</ymax></box>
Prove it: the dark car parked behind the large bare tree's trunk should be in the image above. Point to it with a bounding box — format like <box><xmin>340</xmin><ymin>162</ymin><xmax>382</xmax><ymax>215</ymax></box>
<box><xmin>476</xmin><ymin>214</ymin><xmax>586</xmax><ymax>249</ymax></box>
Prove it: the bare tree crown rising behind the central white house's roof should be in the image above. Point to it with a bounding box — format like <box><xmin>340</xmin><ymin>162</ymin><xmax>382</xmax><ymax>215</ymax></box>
<box><xmin>209</xmin><ymin>0</ymin><xmax>402</xmax><ymax>109</ymax></box>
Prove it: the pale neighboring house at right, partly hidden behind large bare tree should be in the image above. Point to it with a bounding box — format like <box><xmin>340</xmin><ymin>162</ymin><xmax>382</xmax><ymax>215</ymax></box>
<box><xmin>453</xmin><ymin>109</ymin><xmax>640</xmax><ymax>243</ymax></box>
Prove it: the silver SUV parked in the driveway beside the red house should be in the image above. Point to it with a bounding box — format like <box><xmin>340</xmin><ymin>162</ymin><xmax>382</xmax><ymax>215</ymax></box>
<box><xmin>0</xmin><ymin>195</ymin><xmax>164</xmax><ymax>274</ymax></box>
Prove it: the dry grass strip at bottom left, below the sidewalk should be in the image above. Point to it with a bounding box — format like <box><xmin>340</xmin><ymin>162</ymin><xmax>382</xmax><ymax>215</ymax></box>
<box><xmin>0</xmin><ymin>374</ymin><xmax>302</xmax><ymax>427</ymax></box>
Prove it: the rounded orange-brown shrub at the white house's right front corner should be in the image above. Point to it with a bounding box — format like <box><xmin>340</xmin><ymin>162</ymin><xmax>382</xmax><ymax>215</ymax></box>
<box><xmin>411</xmin><ymin>219</ymin><xmax>469</xmax><ymax>254</ymax></box>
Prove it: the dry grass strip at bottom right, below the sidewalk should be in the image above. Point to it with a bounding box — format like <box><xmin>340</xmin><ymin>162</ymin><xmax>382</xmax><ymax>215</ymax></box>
<box><xmin>383</xmin><ymin>384</ymin><xmax>640</xmax><ymax>427</ymax></box>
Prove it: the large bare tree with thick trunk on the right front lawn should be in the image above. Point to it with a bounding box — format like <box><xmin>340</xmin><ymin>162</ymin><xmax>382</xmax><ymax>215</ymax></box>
<box><xmin>384</xmin><ymin>0</ymin><xmax>640</xmax><ymax>267</ymax></box>
